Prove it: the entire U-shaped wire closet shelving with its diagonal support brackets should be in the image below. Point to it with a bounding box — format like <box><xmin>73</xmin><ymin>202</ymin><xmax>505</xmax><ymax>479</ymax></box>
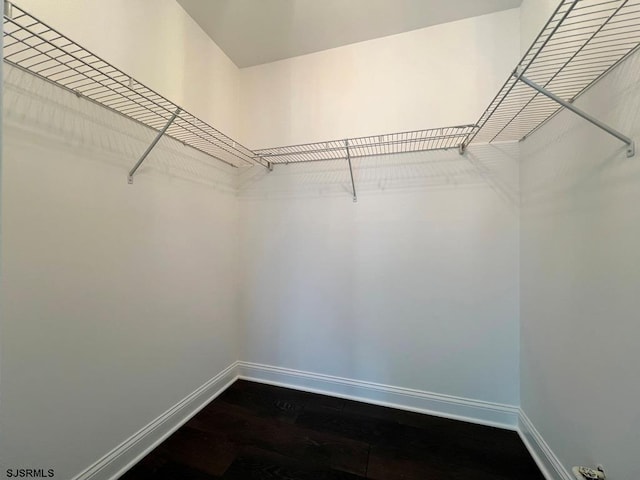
<box><xmin>3</xmin><ymin>0</ymin><xmax>640</xmax><ymax>194</ymax></box>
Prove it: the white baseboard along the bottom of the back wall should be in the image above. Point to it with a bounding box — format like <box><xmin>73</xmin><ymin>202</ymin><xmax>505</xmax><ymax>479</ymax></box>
<box><xmin>238</xmin><ymin>362</ymin><xmax>518</xmax><ymax>430</ymax></box>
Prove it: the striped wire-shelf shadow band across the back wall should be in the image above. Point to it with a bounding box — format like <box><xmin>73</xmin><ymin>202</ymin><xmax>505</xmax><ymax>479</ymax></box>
<box><xmin>238</xmin><ymin>143</ymin><xmax>519</xmax><ymax>209</ymax></box>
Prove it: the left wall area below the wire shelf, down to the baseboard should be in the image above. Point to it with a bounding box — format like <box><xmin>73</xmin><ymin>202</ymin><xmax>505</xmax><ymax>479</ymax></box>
<box><xmin>0</xmin><ymin>13</ymin><xmax>238</xmax><ymax>479</ymax></box>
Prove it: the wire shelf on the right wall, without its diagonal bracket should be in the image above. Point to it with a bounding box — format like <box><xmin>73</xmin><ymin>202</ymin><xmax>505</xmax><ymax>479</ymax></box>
<box><xmin>465</xmin><ymin>0</ymin><xmax>640</xmax><ymax>145</ymax></box>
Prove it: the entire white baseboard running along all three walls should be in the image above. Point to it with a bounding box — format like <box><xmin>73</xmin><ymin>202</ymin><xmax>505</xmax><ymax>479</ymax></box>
<box><xmin>73</xmin><ymin>362</ymin><xmax>524</xmax><ymax>480</ymax></box>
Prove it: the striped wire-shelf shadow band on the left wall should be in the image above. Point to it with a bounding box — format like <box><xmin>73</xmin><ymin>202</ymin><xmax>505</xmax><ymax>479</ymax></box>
<box><xmin>3</xmin><ymin>65</ymin><xmax>237</xmax><ymax>192</ymax></box>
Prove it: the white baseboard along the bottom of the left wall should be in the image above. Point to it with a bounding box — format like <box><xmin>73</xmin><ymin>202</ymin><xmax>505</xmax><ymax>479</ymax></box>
<box><xmin>73</xmin><ymin>362</ymin><xmax>238</xmax><ymax>480</ymax></box>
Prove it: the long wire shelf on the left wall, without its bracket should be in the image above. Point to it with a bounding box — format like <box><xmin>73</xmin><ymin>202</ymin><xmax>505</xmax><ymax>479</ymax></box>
<box><xmin>3</xmin><ymin>3</ymin><xmax>268</xmax><ymax>167</ymax></box>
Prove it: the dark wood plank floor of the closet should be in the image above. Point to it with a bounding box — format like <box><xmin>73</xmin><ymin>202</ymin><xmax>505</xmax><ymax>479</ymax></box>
<box><xmin>121</xmin><ymin>380</ymin><xmax>544</xmax><ymax>480</ymax></box>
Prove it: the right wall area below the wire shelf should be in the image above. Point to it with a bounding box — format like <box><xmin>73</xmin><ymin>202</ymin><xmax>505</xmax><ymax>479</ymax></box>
<box><xmin>521</xmin><ymin>38</ymin><xmax>640</xmax><ymax>480</ymax></box>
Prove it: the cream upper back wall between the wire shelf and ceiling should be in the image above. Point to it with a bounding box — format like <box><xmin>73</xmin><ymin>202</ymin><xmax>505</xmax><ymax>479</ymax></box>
<box><xmin>240</xmin><ymin>9</ymin><xmax>519</xmax><ymax>148</ymax></box>
